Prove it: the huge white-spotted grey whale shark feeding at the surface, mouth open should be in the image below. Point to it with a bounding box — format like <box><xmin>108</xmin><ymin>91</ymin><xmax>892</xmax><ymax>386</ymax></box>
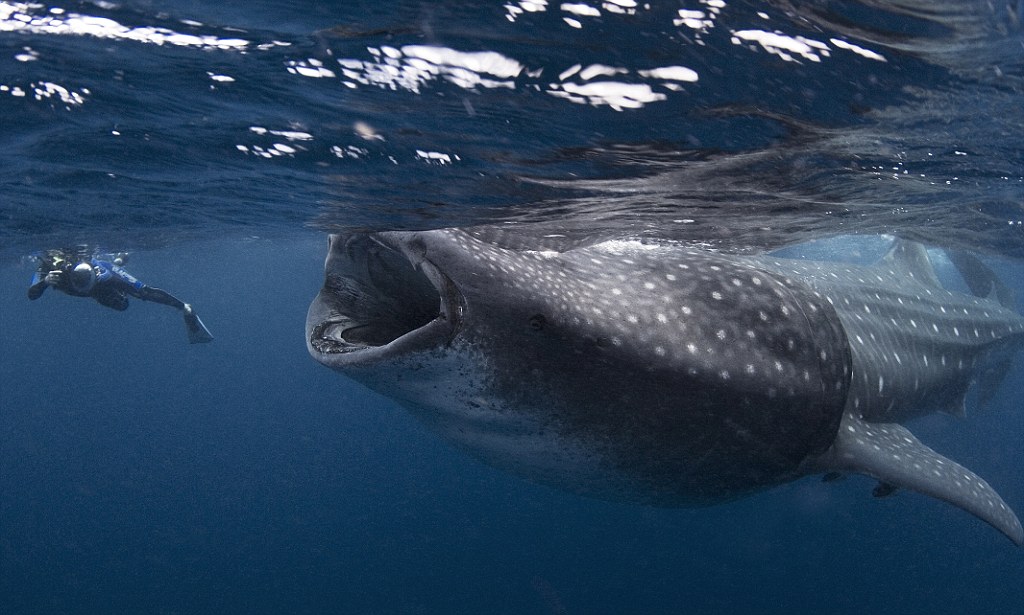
<box><xmin>306</xmin><ymin>227</ymin><xmax>1024</xmax><ymax>545</ymax></box>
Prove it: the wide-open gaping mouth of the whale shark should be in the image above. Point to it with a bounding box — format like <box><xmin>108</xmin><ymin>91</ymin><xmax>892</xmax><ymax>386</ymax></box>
<box><xmin>306</xmin><ymin>235</ymin><xmax>463</xmax><ymax>365</ymax></box>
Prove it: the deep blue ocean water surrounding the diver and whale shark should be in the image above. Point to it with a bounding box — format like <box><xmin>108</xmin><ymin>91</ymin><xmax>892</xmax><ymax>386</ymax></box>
<box><xmin>0</xmin><ymin>0</ymin><xmax>1024</xmax><ymax>613</ymax></box>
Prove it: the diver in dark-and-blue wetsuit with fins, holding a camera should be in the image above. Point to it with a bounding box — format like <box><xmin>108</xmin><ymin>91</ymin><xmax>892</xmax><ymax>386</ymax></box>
<box><xmin>29</xmin><ymin>250</ymin><xmax>213</xmax><ymax>344</ymax></box>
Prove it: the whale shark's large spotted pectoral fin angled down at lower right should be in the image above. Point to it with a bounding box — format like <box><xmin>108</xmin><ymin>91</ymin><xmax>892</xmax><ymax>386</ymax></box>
<box><xmin>815</xmin><ymin>413</ymin><xmax>1024</xmax><ymax>545</ymax></box>
